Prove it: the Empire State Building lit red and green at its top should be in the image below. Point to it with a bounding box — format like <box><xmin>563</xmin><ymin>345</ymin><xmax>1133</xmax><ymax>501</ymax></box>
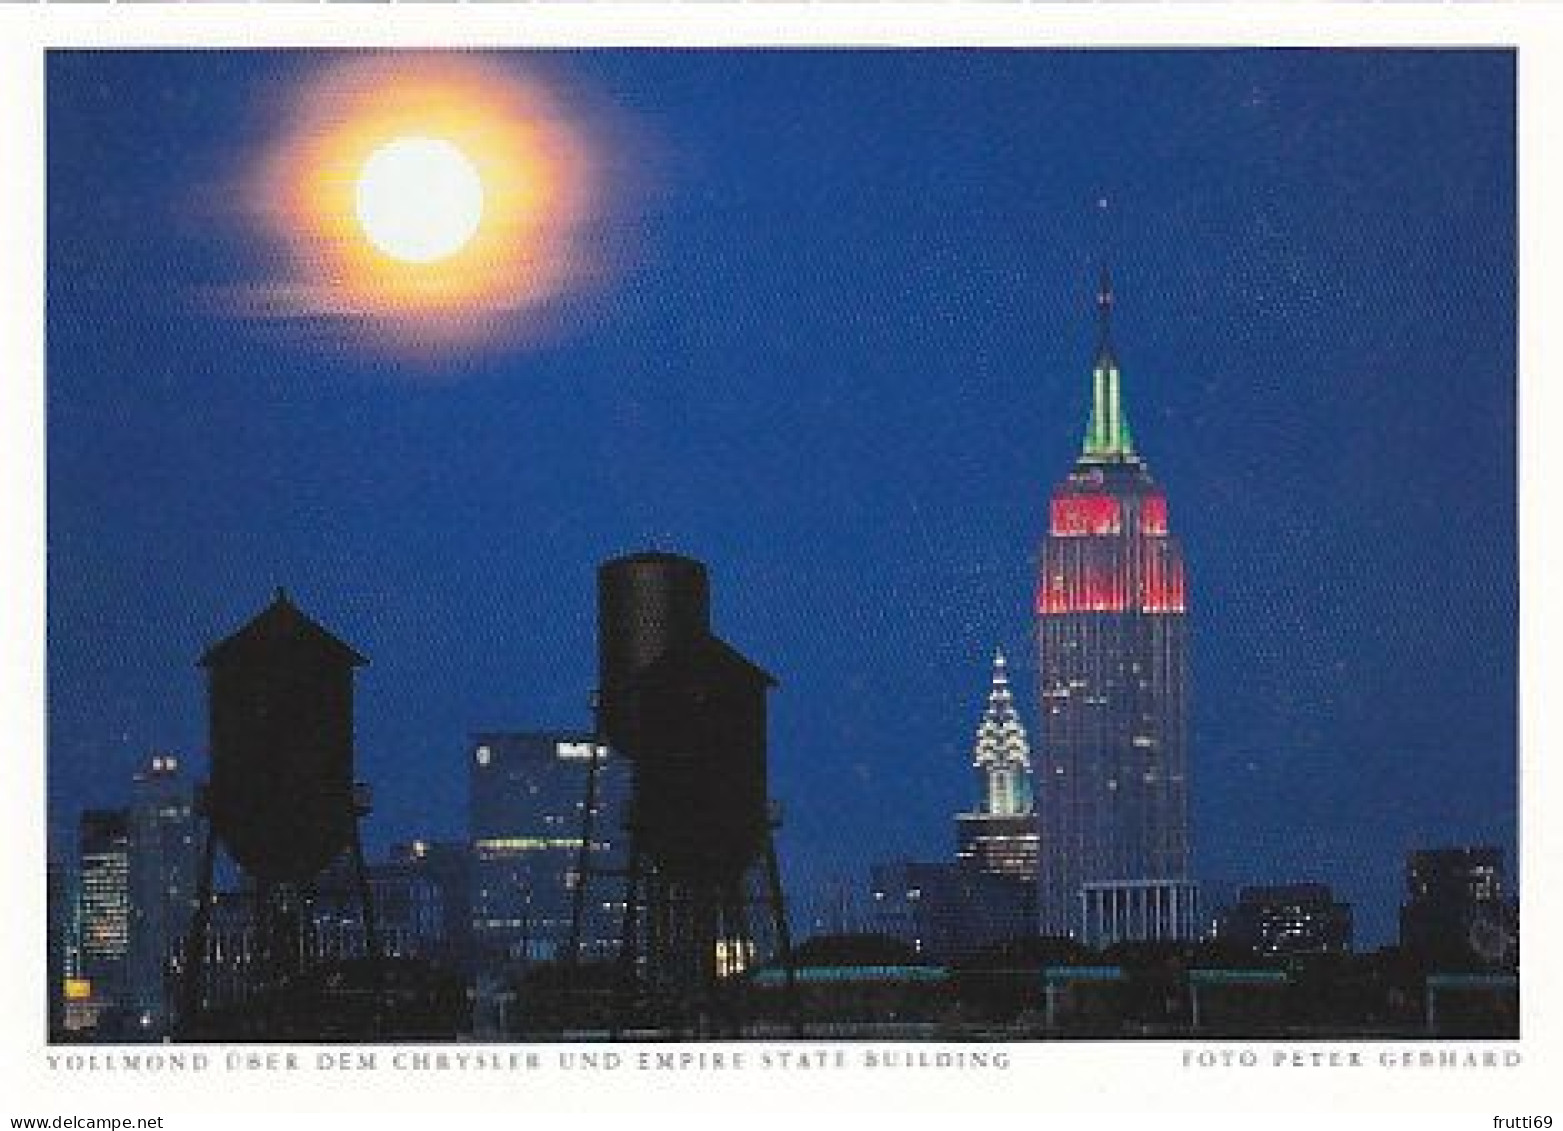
<box><xmin>1035</xmin><ymin>273</ymin><xmax>1199</xmax><ymax>947</ymax></box>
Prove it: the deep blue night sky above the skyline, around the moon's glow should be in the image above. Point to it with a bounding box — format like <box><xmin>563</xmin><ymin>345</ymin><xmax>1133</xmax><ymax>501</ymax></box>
<box><xmin>48</xmin><ymin>50</ymin><xmax>1518</xmax><ymax>942</ymax></box>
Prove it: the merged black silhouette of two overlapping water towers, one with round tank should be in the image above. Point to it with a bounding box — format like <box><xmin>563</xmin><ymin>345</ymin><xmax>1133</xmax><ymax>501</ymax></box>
<box><xmin>597</xmin><ymin>553</ymin><xmax>792</xmax><ymax>1034</ymax></box>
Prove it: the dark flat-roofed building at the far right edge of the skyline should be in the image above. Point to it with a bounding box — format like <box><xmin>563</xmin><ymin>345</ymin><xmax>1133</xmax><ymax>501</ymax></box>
<box><xmin>1400</xmin><ymin>845</ymin><xmax>1519</xmax><ymax>970</ymax></box>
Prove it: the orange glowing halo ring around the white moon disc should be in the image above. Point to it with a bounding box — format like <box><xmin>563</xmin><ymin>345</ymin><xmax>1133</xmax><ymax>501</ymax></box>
<box><xmin>252</xmin><ymin>55</ymin><xmax>596</xmax><ymax>342</ymax></box>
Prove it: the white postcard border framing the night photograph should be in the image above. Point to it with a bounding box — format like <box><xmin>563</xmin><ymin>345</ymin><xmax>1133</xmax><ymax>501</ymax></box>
<box><xmin>0</xmin><ymin>0</ymin><xmax>1563</xmax><ymax>1128</ymax></box>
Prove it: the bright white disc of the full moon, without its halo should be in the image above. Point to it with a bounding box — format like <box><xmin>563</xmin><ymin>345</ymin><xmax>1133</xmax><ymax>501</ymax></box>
<box><xmin>353</xmin><ymin>137</ymin><xmax>483</xmax><ymax>264</ymax></box>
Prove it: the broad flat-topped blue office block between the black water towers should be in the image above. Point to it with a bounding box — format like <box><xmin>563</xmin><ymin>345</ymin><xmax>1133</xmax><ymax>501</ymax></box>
<box><xmin>467</xmin><ymin>731</ymin><xmax>628</xmax><ymax>967</ymax></box>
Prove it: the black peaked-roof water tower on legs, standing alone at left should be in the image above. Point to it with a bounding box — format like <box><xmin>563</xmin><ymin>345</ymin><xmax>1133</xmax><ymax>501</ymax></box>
<box><xmin>180</xmin><ymin>589</ymin><xmax>380</xmax><ymax>1036</ymax></box>
